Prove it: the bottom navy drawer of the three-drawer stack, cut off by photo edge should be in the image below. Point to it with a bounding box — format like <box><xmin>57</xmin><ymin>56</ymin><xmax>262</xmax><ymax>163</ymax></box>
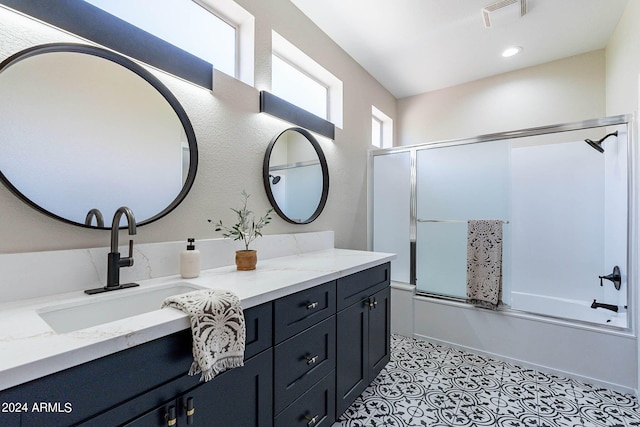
<box><xmin>273</xmin><ymin>371</ymin><xmax>336</xmax><ymax>427</ymax></box>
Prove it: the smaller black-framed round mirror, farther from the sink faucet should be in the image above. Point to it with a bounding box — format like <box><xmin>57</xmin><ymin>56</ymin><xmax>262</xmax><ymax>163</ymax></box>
<box><xmin>262</xmin><ymin>128</ymin><xmax>329</xmax><ymax>224</ymax></box>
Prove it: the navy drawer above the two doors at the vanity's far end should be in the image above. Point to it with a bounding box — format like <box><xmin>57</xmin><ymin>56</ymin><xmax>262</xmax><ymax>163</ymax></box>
<box><xmin>337</xmin><ymin>263</ymin><xmax>391</xmax><ymax>310</ymax></box>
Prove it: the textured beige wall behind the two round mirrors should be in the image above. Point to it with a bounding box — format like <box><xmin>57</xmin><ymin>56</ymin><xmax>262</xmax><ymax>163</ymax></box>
<box><xmin>0</xmin><ymin>0</ymin><xmax>396</xmax><ymax>253</ymax></box>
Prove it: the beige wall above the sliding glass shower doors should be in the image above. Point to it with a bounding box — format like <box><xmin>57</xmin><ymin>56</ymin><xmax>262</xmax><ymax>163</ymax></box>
<box><xmin>397</xmin><ymin>50</ymin><xmax>605</xmax><ymax>145</ymax></box>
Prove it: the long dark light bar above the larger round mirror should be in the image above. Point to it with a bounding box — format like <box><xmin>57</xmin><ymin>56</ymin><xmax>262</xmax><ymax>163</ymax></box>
<box><xmin>0</xmin><ymin>0</ymin><xmax>213</xmax><ymax>90</ymax></box>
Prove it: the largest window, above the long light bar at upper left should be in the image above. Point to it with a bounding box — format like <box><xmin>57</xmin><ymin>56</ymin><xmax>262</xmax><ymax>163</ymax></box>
<box><xmin>85</xmin><ymin>0</ymin><xmax>253</xmax><ymax>84</ymax></box>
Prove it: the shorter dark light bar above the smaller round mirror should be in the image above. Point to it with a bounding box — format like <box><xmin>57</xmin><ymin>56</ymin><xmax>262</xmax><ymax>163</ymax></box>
<box><xmin>260</xmin><ymin>90</ymin><xmax>336</xmax><ymax>139</ymax></box>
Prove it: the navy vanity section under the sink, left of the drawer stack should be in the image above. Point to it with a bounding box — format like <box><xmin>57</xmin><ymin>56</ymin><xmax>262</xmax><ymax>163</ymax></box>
<box><xmin>0</xmin><ymin>303</ymin><xmax>273</xmax><ymax>427</ymax></box>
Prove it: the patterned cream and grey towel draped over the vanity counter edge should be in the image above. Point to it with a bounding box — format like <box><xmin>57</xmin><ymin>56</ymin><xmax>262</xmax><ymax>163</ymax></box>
<box><xmin>162</xmin><ymin>289</ymin><xmax>246</xmax><ymax>381</ymax></box>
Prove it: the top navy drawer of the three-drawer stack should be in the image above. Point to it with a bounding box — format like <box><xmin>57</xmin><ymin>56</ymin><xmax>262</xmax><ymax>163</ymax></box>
<box><xmin>273</xmin><ymin>281</ymin><xmax>336</xmax><ymax>344</ymax></box>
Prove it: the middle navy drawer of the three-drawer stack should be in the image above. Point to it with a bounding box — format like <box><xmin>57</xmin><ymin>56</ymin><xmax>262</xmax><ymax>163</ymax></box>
<box><xmin>274</xmin><ymin>316</ymin><xmax>336</xmax><ymax>414</ymax></box>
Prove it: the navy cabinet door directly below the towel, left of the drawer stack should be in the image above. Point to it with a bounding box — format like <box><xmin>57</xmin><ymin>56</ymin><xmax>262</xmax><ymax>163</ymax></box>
<box><xmin>178</xmin><ymin>349</ymin><xmax>273</xmax><ymax>427</ymax></box>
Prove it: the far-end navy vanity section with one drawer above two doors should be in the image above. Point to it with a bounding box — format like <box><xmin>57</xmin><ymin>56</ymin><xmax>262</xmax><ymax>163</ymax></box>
<box><xmin>336</xmin><ymin>263</ymin><xmax>391</xmax><ymax>416</ymax></box>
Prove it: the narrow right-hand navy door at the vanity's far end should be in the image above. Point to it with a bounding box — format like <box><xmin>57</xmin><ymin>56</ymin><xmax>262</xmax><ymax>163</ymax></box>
<box><xmin>369</xmin><ymin>287</ymin><xmax>391</xmax><ymax>382</ymax></box>
